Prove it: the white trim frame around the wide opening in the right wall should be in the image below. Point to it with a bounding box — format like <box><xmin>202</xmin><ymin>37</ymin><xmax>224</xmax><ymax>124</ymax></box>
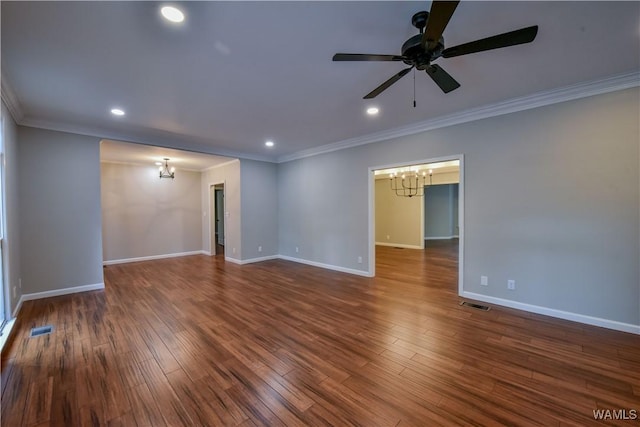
<box><xmin>367</xmin><ymin>154</ymin><xmax>465</xmax><ymax>295</ymax></box>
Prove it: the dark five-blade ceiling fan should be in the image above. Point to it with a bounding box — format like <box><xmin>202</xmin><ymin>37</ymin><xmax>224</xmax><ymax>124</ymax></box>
<box><xmin>333</xmin><ymin>0</ymin><xmax>538</xmax><ymax>99</ymax></box>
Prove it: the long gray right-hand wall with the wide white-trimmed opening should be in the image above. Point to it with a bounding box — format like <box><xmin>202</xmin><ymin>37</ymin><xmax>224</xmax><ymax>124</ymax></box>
<box><xmin>278</xmin><ymin>88</ymin><xmax>640</xmax><ymax>325</ymax></box>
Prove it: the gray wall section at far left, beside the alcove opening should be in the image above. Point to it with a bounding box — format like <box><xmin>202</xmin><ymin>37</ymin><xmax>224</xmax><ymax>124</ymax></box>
<box><xmin>18</xmin><ymin>126</ymin><xmax>103</xmax><ymax>294</ymax></box>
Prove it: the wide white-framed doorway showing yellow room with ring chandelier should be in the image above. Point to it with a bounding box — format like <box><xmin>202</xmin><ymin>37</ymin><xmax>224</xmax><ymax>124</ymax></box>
<box><xmin>369</xmin><ymin>155</ymin><xmax>464</xmax><ymax>294</ymax></box>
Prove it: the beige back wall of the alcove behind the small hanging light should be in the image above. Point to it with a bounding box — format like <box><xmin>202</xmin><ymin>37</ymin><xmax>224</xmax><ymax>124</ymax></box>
<box><xmin>100</xmin><ymin>163</ymin><xmax>202</xmax><ymax>261</ymax></box>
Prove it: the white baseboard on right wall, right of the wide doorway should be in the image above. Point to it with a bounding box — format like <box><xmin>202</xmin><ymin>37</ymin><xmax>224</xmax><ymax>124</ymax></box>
<box><xmin>460</xmin><ymin>291</ymin><xmax>640</xmax><ymax>335</ymax></box>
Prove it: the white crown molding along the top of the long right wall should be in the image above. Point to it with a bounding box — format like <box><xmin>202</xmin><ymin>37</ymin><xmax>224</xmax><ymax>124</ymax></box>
<box><xmin>278</xmin><ymin>72</ymin><xmax>640</xmax><ymax>163</ymax></box>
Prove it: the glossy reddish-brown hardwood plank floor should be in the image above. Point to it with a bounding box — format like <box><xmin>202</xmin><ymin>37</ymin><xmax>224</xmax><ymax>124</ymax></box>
<box><xmin>1</xmin><ymin>243</ymin><xmax>640</xmax><ymax>426</ymax></box>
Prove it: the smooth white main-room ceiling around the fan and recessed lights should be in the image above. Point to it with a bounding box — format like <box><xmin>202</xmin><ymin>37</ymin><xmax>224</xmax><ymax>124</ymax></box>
<box><xmin>1</xmin><ymin>1</ymin><xmax>640</xmax><ymax>160</ymax></box>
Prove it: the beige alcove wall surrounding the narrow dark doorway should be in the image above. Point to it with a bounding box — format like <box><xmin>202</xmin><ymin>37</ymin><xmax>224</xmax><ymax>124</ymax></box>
<box><xmin>200</xmin><ymin>160</ymin><xmax>242</xmax><ymax>261</ymax></box>
